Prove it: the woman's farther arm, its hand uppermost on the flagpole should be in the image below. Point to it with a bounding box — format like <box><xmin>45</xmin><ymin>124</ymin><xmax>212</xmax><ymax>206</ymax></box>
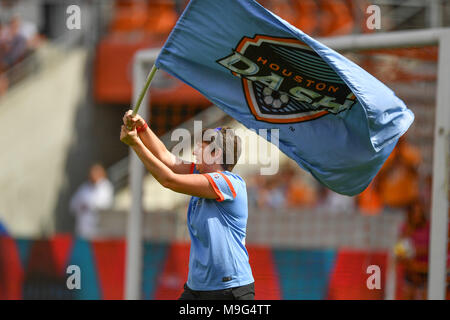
<box><xmin>123</xmin><ymin>110</ymin><xmax>191</xmax><ymax>174</ymax></box>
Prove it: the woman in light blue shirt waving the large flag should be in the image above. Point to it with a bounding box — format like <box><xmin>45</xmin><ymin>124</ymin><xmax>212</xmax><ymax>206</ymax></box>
<box><xmin>120</xmin><ymin>110</ymin><xmax>255</xmax><ymax>300</ymax></box>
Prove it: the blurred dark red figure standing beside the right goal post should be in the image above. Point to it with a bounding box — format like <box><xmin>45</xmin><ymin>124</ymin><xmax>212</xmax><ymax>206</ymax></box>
<box><xmin>394</xmin><ymin>201</ymin><xmax>430</xmax><ymax>300</ymax></box>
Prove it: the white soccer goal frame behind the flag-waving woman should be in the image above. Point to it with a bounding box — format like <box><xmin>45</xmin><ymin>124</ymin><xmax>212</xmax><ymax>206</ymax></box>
<box><xmin>125</xmin><ymin>28</ymin><xmax>450</xmax><ymax>299</ymax></box>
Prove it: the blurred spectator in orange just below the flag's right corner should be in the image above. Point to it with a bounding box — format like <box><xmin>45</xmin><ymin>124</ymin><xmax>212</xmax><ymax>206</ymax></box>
<box><xmin>377</xmin><ymin>137</ymin><xmax>421</xmax><ymax>208</ymax></box>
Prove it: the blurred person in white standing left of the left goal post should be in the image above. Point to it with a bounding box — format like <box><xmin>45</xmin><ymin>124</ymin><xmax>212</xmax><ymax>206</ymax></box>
<box><xmin>70</xmin><ymin>164</ymin><xmax>113</xmax><ymax>239</ymax></box>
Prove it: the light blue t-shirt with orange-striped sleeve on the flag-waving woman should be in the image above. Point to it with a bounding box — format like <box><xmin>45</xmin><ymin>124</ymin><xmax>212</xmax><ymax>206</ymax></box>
<box><xmin>187</xmin><ymin>168</ymin><xmax>254</xmax><ymax>291</ymax></box>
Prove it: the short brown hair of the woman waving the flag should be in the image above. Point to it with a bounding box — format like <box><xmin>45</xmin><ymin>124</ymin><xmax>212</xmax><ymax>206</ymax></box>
<box><xmin>202</xmin><ymin>127</ymin><xmax>241</xmax><ymax>171</ymax></box>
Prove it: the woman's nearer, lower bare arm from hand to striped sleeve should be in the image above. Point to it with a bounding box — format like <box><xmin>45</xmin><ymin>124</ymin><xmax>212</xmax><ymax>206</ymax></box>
<box><xmin>120</xmin><ymin>125</ymin><xmax>218</xmax><ymax>199</ymax></box>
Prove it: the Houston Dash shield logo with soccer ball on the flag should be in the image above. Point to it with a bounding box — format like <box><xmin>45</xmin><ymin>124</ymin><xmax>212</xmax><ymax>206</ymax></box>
<box><xmin>217</xmin><ymin>35</ymin><xmax>356</xmax><ymax>123</ymax></box>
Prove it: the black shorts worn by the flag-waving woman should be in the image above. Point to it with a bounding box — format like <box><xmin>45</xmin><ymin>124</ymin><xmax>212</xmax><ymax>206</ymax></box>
<box><xmin>178</xmin><ymin>282</ymin><xmax>255</xmax><ymax>300</ymax></box>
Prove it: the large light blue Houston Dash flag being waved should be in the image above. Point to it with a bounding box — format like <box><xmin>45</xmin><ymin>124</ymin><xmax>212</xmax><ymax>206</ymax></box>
<box><xmin>156</xmin><ymin>0</ymin><xmax>414</xmax><ymax>195</ymax></box>
